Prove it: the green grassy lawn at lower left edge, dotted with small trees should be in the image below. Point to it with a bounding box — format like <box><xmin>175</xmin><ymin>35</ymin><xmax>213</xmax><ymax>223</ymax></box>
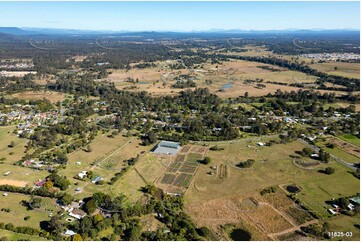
<box><xmin>0</xmin><ymin>192</ymin><xmax>60</xmax><ymax>229</ymax></box>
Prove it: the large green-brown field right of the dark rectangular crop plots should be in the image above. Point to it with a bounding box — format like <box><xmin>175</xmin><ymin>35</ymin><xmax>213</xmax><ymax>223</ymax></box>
<box><xmin>185</xmin><ymin>140</ymin><xmax>360</xmax><ymax>238</ymax></box>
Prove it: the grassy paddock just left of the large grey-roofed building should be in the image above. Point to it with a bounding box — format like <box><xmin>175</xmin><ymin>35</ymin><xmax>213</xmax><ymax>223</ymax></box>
<box><xmin>60</xmin><ymin>131</ymin><xmax>155</xmax><ymax>200</ymax></box>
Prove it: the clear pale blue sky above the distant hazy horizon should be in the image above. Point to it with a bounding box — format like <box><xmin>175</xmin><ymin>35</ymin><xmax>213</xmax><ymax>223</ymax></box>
<box><xmin>0</xmin><ymin>1</ymin><xmax>360</xmax><ymax>31</ymax></box>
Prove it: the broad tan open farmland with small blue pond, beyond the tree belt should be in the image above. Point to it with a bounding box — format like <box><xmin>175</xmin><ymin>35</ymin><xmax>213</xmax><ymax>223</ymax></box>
<box><xmin>110</xmin><ymin>60</ymin><xmax>344</xmax><ymax>98</ymax></box>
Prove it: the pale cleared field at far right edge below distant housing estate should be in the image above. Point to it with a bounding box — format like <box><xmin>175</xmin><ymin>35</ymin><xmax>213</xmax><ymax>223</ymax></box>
<box><xmin>311</xmin><ymin>62</ymin><xmax>360</xmax><ymax>79</ymax></box>
